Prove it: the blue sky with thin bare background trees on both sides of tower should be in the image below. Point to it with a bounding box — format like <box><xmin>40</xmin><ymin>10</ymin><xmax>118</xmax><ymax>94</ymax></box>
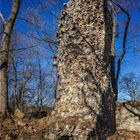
<box><xmin>0</xmin><ymin>0</ymin><xmax>140</xmax><ymax>114</ymax></box>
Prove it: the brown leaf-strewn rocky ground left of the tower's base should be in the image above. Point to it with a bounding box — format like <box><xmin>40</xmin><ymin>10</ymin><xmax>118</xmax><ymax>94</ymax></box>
<box><xmin>0</xmin><ymin>108</ymin><xmax>52</xmax><ymax>140</ymax></box>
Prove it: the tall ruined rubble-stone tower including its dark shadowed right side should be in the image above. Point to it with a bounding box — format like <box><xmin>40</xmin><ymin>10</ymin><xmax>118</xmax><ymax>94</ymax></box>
<box><xmin>52</xmin><ymin>0</ymin><xmax>114</xmax><ymax>140</ymax></box>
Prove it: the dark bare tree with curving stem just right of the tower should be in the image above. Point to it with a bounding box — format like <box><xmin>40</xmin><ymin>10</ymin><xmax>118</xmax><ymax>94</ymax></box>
<box><xmin>110</xmin><ymin>0</ymin><xmax>131</xmax><ymax>100</ymax></box>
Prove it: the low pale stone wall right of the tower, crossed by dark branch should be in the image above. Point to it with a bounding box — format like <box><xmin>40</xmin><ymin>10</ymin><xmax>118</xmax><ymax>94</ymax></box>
<box><xmin>116</xmin><ymin>101</ymin><xmax>140</xmax><ymax>133</ymax></box>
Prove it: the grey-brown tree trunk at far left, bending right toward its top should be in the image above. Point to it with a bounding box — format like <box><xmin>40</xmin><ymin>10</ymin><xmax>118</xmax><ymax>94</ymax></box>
<box><xmin>0</xmin><ymin>0</ymin><xmax>21</xmax><ymax>114</ymax></box>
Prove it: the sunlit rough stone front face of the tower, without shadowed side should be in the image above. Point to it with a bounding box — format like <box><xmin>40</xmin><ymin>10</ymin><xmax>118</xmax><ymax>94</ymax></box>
<box><xmin>55</xmin><ymin>0</ymin><xmax>111</xmax><ymax>117</ymax></box>
